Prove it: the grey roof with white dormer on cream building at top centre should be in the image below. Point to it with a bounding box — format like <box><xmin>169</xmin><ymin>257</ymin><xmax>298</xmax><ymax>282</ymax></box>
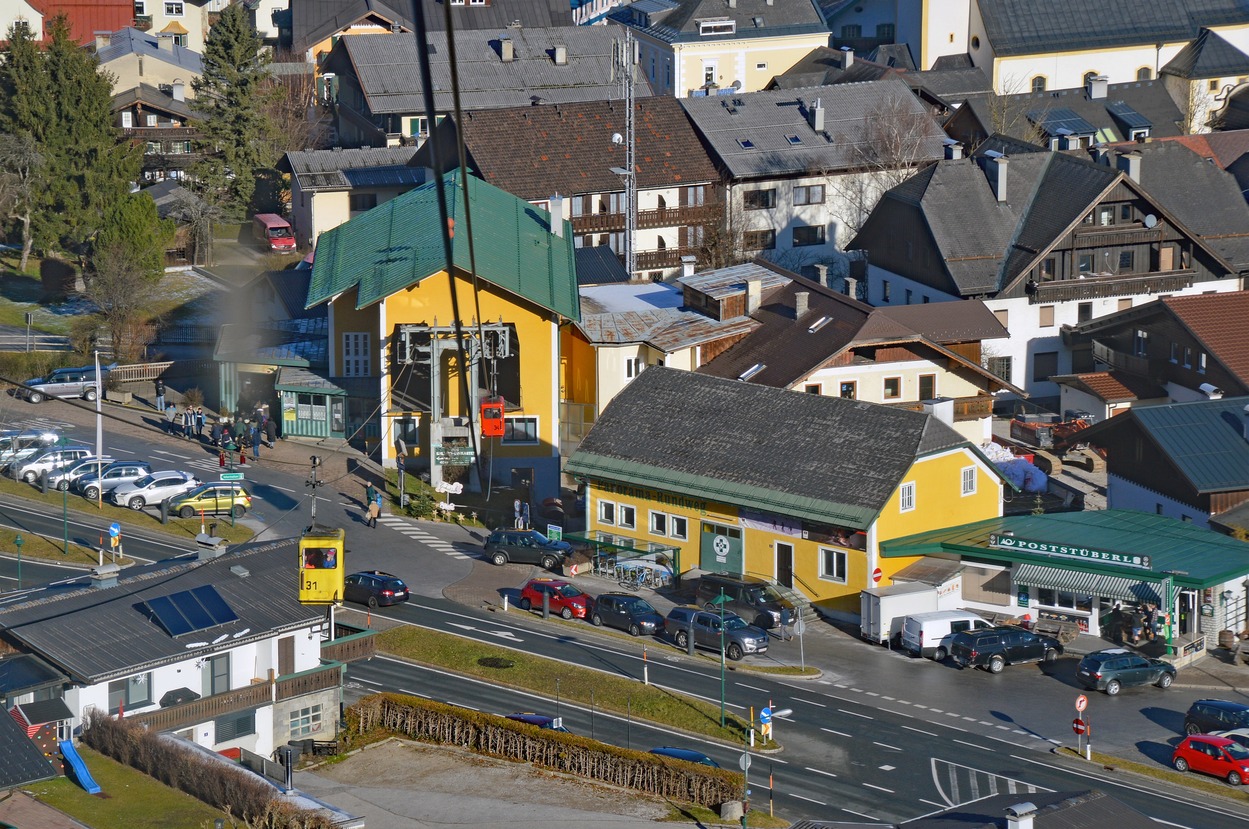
<box><xmin>607</xmin><ymin>0</ymin><xmax>827</xmax><ymax>44</ymax></box>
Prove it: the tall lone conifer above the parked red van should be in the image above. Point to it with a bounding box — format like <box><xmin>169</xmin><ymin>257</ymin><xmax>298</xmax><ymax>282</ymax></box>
<box><xmin>191</xmin><ymin>2</ymin><xmax>272</xmax><ymax>217</ymax></box>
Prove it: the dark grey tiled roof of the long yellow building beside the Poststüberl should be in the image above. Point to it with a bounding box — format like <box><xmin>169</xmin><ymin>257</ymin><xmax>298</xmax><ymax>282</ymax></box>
<box><xmin>567</xmin><ymin>366</ymin><xmax>968</xmax><ymax>528</ymax></box>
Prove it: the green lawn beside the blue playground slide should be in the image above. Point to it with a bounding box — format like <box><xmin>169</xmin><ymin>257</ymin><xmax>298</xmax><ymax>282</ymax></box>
<box><xmin>30</xmin><ymin>745</ymin><xmax>231</xmax><ymax>829</ymax></box>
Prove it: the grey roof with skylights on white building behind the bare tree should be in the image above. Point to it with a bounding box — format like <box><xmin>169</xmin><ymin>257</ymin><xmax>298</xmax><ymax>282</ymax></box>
<box><xmin>681</xmin><ymin>77</ymin><xmax>944</xmax><ymax>179</ymax></box>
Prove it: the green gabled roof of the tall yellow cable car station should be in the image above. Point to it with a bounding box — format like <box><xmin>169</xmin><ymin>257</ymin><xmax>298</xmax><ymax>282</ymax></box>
<box><xmin>307</xmin><ymin>171</ymin><xmax>580</xmax><ymax>320</ymax></box>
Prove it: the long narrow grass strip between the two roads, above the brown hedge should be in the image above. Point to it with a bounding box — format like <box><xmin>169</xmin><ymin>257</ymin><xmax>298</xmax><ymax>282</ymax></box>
<box><xmin>378</xmin><ymin>625</ymin><xmax>766</xmax><ymax>748</ymax></box>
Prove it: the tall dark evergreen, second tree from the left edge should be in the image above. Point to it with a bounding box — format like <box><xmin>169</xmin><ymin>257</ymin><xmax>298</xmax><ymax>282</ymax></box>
<box><xmin>36</xmin><ymin>16</ymin><xmax>140</xmax><ymax>258</ymax></box>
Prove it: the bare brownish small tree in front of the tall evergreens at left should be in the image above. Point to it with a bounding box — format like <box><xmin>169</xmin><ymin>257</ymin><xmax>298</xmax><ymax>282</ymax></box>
<box><xmin>84</xmin><ymin>235</ymin><xmax>160</xmax><ymax>362</ymax></box>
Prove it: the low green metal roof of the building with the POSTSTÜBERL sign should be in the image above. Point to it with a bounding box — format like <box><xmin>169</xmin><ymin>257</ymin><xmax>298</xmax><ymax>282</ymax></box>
<box><xmin>881</xmin><ymin>509</ymin><xmax>1249</xmax><ymax>588</ymax></box>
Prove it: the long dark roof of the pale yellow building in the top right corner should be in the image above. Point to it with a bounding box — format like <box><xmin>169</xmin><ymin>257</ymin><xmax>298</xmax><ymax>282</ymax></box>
<box><xmin>978</xmin><ymin>0</ymin><xmax>1249</xmax><ymax>57</ymax></box>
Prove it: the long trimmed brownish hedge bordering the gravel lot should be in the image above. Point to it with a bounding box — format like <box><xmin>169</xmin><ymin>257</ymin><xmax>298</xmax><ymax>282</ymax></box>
<box><xmin>348</xmin><ymin>693</ymin><xmax>743</xmax><ymax>808</ymax></box>
